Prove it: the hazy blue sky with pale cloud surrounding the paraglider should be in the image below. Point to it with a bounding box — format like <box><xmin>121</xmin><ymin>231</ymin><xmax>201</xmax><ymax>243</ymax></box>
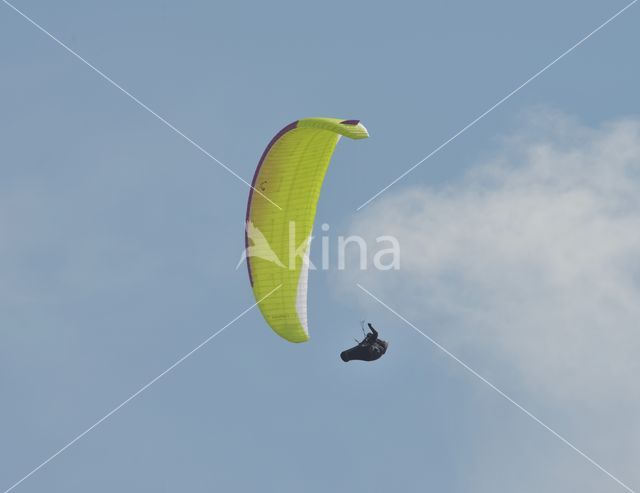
<box><xmin>0</xmin><ymin>0</ymin><xmax>640</xmax><ymax>493</ymax></box>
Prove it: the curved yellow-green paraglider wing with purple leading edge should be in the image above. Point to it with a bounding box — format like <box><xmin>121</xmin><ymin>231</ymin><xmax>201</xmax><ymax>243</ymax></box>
<box><xmin>245</xmin><ymin>118</ymin><xmax>369</xmax><ymax>342</ymax></box>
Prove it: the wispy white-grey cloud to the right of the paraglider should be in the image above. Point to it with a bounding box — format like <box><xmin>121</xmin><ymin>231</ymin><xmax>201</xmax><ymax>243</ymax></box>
<box><xmin>350</xmin><ymin>111</ymin><xmax>640</xmax><ymax>491</ymax></box>
